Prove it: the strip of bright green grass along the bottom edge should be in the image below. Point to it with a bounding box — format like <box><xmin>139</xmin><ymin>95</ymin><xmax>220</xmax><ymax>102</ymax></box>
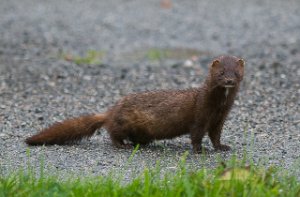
<box><xmin>0</xmin><ymin>152</ymin><xmax>300</xmax><ymax>197</ymax></box>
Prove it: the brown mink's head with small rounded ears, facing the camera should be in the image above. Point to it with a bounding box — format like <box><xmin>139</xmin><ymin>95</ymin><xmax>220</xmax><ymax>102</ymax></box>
<box><xmin>210</xmin><ymin>56</ymin><xmax>245</xmax><ymax>88</ymax></box>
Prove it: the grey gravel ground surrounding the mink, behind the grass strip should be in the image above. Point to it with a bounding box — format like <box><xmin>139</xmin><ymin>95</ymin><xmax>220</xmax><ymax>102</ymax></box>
<box><xmin>0</xmin><ymin>0</ymin><xmax>300</xmax><ymax>177</ymax></box>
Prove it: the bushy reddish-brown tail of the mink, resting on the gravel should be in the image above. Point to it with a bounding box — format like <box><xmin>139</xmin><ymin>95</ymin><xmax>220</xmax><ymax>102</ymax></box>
<box><xmin>25</xmin><ymin>114</ymin><xmax>106</xmax><ymax>145</ymax></box>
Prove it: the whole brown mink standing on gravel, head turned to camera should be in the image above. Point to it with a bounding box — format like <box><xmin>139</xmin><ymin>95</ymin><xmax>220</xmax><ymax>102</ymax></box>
<box><xmin>26</xmin><ymin>56</ymin><xmax>244</xmax><ymax>152</ymax></box>
